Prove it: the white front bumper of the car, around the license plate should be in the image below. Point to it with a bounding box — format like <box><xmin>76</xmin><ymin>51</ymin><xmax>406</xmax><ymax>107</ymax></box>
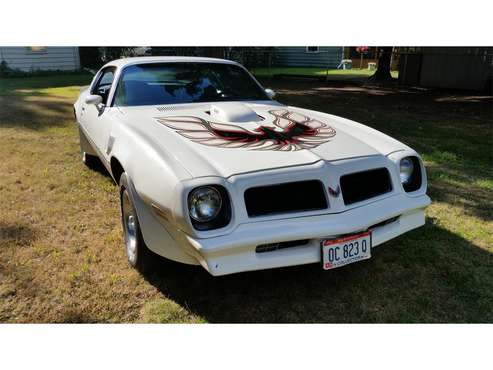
<box><xmin>175</xmin><ymin>194</ymin><xmax>430</xmax><ymax>276</ymax></box>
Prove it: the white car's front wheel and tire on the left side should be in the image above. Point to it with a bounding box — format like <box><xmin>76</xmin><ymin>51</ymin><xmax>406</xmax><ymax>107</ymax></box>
<box><xmin>120</xmin><ymin>173</ymin><xmax>152</xmax><ymax>272</ymax></box>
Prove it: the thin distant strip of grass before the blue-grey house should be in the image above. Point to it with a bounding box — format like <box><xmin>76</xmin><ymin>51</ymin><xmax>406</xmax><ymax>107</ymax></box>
<box><xmin>251</xmin><ymin>67</ymin><xmax>399</xmax><ymax>78</ymax></box>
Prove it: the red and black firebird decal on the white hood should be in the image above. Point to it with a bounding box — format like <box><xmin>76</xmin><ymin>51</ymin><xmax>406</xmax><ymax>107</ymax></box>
<box><xmin>156</xmin><ymin>109</ymin><xmax>336</xmax><ymax>151</ymax></box>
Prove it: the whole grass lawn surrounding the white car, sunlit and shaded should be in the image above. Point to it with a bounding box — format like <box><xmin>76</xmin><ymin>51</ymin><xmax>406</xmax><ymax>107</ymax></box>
<box><xmin>0</xmin><ymin>75</ymin><xmax>493</xmax><ymax>323</ymax></box>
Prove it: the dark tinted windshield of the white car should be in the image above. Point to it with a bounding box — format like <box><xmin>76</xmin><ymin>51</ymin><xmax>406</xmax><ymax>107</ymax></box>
<box><xmin>115</xmin><ymin>62</ymin><xmax>269</xmax><ymax>106</ymax></box>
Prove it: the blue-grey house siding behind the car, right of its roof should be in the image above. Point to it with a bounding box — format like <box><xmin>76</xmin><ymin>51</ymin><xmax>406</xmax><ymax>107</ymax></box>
<box><xmin>274</xmin><ymin>46</ymin><xmax>343</xmax><ymax>68</ymax></box>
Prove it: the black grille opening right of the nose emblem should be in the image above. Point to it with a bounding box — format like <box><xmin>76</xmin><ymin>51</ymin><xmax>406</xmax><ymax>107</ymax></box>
<box><xmin>340</xmin><ymin>168</ymin><xmax>392</xmax><ymax>205</ymax></box>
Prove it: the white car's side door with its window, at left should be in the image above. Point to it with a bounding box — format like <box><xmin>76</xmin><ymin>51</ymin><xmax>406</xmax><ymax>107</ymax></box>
<box><xmin>82</xmin><ymin>67</ymin><xmax>116</xmax><ymax>160</ymax></box>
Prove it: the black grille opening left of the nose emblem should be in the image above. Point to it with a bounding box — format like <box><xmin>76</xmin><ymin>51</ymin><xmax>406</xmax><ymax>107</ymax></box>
<box><xmin>245</xmin><ymin>180</ymin><xmax>327</xmax><ymax>217</ymax></box>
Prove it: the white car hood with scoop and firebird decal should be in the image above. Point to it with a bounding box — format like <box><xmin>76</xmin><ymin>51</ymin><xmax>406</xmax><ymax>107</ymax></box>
<box><xmin>118</xmin><ymin>102</ymin><xmax>407</xmax><ymax>177</ymax></box>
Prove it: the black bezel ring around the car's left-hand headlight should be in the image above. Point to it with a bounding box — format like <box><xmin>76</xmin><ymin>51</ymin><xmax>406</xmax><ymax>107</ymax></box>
<box><xmin>187</xmin><ymin>184</ymin><xmax>232</xmax><ymax>231</ymax></box>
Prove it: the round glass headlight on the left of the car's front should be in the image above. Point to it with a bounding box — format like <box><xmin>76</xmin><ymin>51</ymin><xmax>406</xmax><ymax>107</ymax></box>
<box><xmin>188</xmin><ymin>186</ymin><xmax>222</xmax><ymax>222</ymax></box>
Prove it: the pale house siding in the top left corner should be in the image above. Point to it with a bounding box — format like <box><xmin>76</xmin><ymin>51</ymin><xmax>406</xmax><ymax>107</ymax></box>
<box><xmin>0</xmin><ymin>46</ymin><xmax>80</xmax><ymax>71</ymax></box>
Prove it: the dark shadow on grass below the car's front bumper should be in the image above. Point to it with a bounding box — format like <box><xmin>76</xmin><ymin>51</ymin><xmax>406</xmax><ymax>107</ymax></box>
<box><xmin>144</xmin><ymin>218</ymin><xmax>493</xmax><ymax>323</ymax></box>
